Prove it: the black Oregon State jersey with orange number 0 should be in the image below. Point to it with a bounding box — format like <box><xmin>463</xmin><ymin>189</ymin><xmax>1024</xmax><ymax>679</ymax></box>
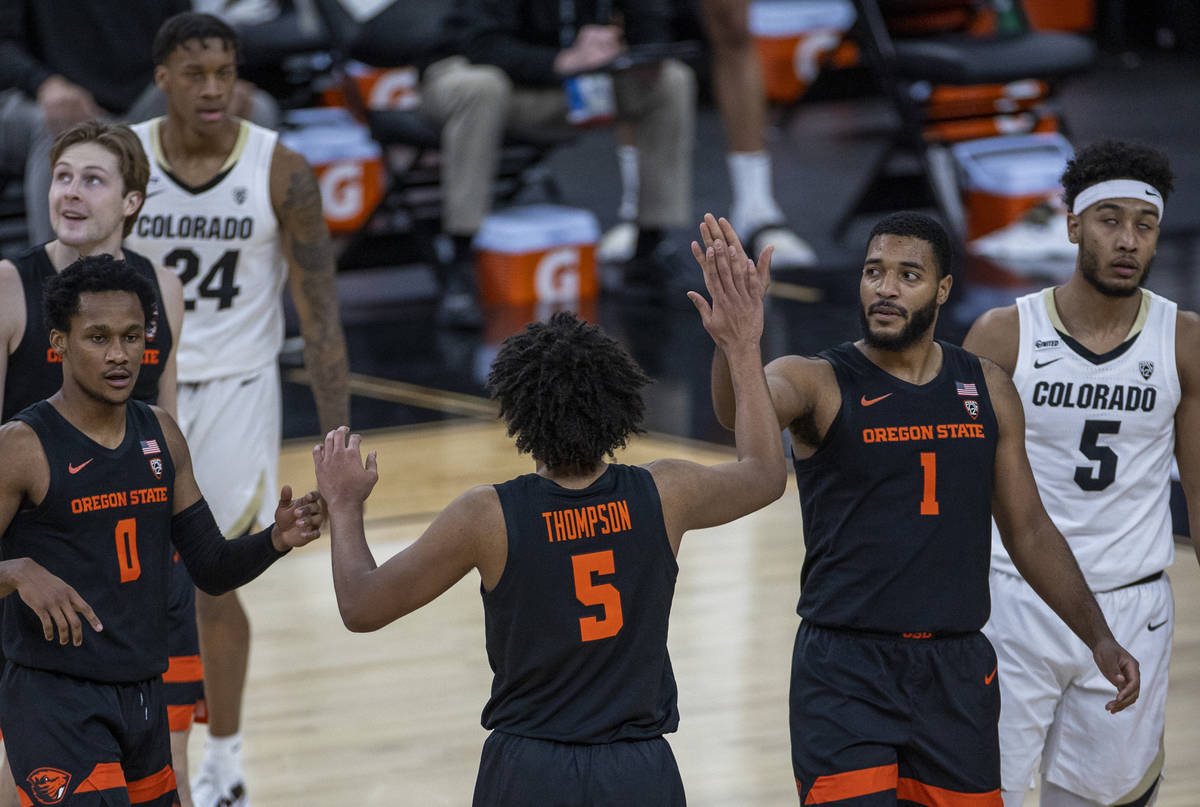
<box><xmin>0</xmin><ymin>401</ymin><xmax>175</xmax><ymax>681</ymax></box>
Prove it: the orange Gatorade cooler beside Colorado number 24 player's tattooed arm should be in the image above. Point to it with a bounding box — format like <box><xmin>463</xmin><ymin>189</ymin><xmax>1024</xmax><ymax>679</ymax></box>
<box><xmin>280</xmin><ymin>108</ymin><xmax>384</xmax><ymax>233</ymax></box>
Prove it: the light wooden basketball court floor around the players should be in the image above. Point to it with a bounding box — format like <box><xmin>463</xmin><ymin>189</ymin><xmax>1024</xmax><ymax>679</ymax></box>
<box><xmin>174</xmin><ymin>413</ymin><xmax>1200</xmax><ymax>807</ymax></box>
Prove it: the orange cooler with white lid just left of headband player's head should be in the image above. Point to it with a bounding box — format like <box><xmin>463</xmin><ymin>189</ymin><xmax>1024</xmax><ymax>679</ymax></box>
<box><xmin>952</xmin><ymin>132</ymin><xmax>1074</xmax><ymax>240</ymax></box>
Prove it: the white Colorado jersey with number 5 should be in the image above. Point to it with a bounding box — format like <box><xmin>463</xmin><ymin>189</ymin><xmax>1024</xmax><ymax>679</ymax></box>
<box><xmin>991</xmin><ymin>288</ymin><xmax>1180</xmax><ymax>591</ymax></box>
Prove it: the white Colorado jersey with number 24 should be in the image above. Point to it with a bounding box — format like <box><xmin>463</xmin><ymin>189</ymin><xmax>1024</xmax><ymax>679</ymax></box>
<box><xmin>126</xmin><ymin>118</ymin><xmax>287</xmax><ymax>383</ymax></box>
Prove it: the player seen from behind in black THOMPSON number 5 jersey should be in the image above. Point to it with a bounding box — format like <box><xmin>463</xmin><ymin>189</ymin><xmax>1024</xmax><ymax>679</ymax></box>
<box><xmin>314</xmin><ymin>236</ymin><xmax>786</xmax><ymax>807</ymax></box>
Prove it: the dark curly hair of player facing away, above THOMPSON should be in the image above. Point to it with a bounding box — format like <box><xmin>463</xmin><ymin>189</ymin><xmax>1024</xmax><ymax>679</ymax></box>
<box><xmin>487</xmin><ymin>311</ymin><xmax>650</xmax><ymax>473</ymax></box>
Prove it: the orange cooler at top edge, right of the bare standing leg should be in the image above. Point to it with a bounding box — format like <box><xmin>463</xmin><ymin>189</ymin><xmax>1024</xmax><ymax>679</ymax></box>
<box><xmin>749</xmin><ymin>0</ymin><xmax>854</xmax><ymax>103</ymax></box>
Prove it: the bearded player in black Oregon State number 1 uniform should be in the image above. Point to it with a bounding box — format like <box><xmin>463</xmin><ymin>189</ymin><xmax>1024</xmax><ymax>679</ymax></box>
<box><xmin>692</xmin><ymin>214</ymin><xmax>1139</xmax><ymax>807</ymax></box>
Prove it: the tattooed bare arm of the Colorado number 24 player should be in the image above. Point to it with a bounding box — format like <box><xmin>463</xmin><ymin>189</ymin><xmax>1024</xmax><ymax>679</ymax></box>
<box><xmin>271</xmin><ymin>145</ymin><xmax>350</xmax><ymax>434</ymax></box>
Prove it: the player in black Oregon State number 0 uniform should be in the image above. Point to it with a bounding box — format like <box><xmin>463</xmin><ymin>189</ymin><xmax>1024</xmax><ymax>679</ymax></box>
<box><xmin>0</xmin><ymin>256</ymin><xmax>323</xmax><ymax>807</ymax></box>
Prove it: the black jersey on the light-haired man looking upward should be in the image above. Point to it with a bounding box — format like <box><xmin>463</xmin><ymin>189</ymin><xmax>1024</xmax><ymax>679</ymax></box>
<box><xmin>0</xmin><ymin>244</ymin><xmax>172</xmax><ymax>423</ymax></box>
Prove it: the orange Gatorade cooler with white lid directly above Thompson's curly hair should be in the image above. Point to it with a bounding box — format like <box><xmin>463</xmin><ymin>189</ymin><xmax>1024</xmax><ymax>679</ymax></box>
<box><xmin>474</xmin><ymin>204</ymin><xmax>600</xmax><ymax>304</ymax></box>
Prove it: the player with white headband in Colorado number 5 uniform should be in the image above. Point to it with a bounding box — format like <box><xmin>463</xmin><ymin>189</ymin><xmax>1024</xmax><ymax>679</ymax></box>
<box><xmin>964</xmin><ymin>141</ymin><xmax>1200</xmax><ymax>807</ymax></box>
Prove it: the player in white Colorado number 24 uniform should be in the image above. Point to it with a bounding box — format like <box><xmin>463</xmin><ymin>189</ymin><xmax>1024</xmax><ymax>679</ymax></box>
<box><xmin>127</xmin><ymin>13</ymin><xmax>349</xmax><ymax>807</ymax></box>
